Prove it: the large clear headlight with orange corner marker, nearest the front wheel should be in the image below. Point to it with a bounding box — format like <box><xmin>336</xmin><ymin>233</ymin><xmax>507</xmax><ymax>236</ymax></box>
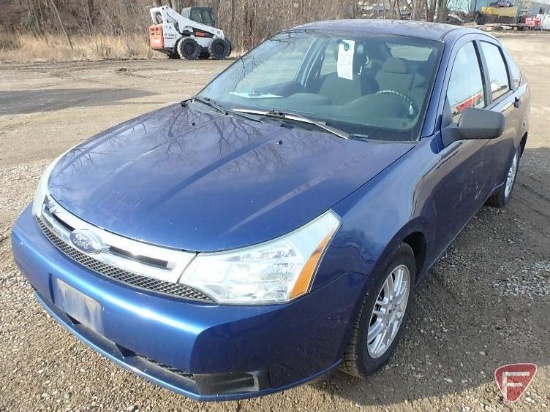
<box><xmin>180</xmin><ymin>211</ymin><xmax>340</xmax><ymax>304</ymax></box>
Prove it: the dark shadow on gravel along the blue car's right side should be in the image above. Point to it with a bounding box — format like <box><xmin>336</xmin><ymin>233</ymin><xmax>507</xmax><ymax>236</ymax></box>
<box><xmin>311</xmin><ymin>148</ymin><xmax>550</xmax><ymax>409</ymax></box>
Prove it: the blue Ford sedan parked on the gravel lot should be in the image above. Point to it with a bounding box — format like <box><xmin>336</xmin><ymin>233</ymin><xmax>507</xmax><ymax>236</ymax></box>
<box><xmin>12</xmin><ymin>20</ymin><xmax>530</xmax><ymax>400</ymax></box>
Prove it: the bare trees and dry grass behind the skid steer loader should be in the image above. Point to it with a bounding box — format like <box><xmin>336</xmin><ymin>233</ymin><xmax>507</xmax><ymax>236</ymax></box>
<box><xmin>7</xmin><ymin>0</ymin><xmax>467</xmax><ymax>50</ymax></box>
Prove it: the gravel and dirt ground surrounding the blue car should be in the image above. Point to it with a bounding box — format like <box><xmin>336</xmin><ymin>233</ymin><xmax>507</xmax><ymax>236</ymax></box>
<box><xmin>0</xmin><ymin>34</ymin><xmax>550</xmax><ymax>411</ymax></box>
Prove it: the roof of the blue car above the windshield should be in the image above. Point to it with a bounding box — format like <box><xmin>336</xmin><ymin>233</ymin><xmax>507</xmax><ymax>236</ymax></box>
<box><xmin>294</xmin><ymin>19</ymin><xmax>490</xmax><ymax>41</ymax></box>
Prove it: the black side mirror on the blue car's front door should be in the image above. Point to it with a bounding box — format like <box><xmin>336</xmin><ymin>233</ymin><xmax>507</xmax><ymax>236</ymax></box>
<box><xmin>441</xmin><ymin>107</ymin><xmax>505</xmax><ymax>146</ymax></box>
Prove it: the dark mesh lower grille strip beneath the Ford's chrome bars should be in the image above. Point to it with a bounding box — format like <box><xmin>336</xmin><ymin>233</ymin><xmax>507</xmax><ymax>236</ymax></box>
<box><xmin>36</xmin><ymin>218</ymin><xmax>214</xmax><ymax>303</ymax></box>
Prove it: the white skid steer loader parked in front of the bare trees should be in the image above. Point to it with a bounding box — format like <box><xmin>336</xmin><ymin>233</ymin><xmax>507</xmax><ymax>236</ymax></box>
<box><xmin>149</xmin><ymin>6</ymin><xmax>231</xmax><ymax>60</ymax></box>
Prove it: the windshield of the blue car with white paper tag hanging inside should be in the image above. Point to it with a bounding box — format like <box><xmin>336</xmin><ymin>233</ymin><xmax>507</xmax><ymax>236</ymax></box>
<box><xmin>199</xmin><ymin>30</ymin><xmax>441</xmax><ymax>141</ymax></box>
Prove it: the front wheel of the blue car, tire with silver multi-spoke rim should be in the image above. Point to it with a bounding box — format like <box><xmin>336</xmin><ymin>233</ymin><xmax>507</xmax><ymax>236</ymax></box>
<box><xmin>341</xmin><ymin>243</ymin><xmax>416</xmax><ymax>378</ymax></box>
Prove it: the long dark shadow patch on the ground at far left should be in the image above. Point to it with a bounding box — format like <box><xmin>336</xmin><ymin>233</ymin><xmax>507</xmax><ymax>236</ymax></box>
<box><xmin>0</xmin><ymin>88</ymin><xmax>156</xmax><ymax>115</ymax></box>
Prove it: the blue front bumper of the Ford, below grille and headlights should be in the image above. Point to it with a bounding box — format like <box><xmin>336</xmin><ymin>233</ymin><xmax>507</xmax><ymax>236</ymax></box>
<box><xmin>12</xmin><ymin>207</ymin><xmax>367</xmax><ymax>400</ymax></box>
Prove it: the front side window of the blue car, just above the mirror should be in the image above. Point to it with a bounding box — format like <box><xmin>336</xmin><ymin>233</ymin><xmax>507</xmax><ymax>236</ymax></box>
<box><xmin>447</xmin><ymin>43</ymin><xmax>485</xmax><ymax>122</ymax></box>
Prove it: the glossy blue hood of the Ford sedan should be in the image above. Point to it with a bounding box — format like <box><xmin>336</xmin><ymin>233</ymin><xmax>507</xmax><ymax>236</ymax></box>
<box><xmin>49</xmin><ymin>105</ymin><xmax>411</xmax><ymax>251</ymax></box>
